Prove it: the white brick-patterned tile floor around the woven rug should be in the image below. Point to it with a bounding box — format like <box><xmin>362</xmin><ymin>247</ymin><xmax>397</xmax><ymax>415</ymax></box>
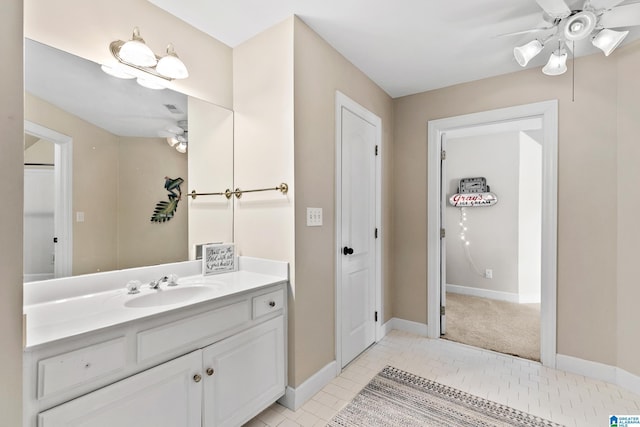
<box><xmin>245</xmin><ymin>331</ymin><xmax>640</xmax><ymax>427</ymax></box>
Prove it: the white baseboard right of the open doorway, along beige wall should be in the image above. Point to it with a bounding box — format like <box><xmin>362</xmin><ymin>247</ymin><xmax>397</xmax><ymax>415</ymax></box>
<box><xmin>556</xmin><ymin>354</ymin><xmax>640</xmax><ymax>394</ymax></box>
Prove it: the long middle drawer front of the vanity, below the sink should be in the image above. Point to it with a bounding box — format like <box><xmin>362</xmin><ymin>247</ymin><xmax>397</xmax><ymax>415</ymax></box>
<box><xmin>138</xmin><ymin>299</ymin><xmax>251</xmax><ymax>362</ymax></box>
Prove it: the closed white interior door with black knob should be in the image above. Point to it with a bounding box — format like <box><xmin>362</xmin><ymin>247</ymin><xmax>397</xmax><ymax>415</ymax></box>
<box><xmin>339</xmin><ymin>106</ymin><xmax>378</xmax><ymax>367</ymax></box>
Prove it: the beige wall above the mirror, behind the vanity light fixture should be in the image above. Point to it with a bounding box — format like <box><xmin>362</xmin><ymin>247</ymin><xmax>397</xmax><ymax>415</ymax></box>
<box><xmin>24</xmin><ymin>0</ymin><xmax>232</xmax><ymax>108</ymax></box>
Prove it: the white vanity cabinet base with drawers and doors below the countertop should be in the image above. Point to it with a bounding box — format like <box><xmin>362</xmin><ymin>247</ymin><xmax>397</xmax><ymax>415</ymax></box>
<box><xmin>25</xmin><ymin>282</ymin><xmax>286</xmax><ymax>427</ymax></box>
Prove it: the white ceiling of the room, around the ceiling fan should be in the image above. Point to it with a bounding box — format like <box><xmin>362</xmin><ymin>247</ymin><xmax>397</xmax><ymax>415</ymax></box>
<box><xmin>149</xmin><ymin>0</ymin><xmax>640</xmax><ymax>98</ymax></box>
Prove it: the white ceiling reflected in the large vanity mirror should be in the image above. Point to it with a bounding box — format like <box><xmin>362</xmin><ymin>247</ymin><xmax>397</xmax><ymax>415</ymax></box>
<box><xmin>25</xmin><ymin>39</ymin><xmax>187</xmax><ymax>137</ymax></box>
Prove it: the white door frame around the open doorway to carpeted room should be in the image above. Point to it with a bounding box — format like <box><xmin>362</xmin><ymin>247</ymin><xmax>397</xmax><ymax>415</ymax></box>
<box><xmin>427</xmin><ymin>100</ymin><xmax>558</xmax><ymax>368</ymax></box>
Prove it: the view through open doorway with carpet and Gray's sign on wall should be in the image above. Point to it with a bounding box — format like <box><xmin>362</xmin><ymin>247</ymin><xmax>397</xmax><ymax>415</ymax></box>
<box><xmin>441</xmin><ymin>124</ymin><xmax>543</xmax><ymax>361</ymax></box>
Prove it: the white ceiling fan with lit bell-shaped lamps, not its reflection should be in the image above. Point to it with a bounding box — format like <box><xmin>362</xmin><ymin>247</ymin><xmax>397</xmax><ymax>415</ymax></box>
<box><xmin>509</xmin><ymin>0</ymin><xmax>640</xmax><ymax>76</ymax></box>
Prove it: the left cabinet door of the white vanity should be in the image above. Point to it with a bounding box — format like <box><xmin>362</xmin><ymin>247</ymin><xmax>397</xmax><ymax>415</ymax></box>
<box><xmin>38</xmin><ymin>350</ymin><xmax>202</xmax><ymax>427</ymax></box>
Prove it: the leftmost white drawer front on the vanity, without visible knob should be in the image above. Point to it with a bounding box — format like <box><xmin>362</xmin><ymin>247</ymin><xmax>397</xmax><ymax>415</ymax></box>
<box><xmin>38</xmin><ymin>337</ymin><xmax>126</xmax><ymax>399</ymax></box>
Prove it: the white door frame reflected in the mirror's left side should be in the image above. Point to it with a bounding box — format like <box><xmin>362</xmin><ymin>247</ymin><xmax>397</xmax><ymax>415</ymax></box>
<box><xmin>24</xmin><ymin>120</ymin><xmax>73</xmax><ymax>278</ymax></box>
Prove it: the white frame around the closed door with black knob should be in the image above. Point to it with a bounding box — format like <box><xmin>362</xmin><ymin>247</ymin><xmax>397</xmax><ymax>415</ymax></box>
<box><xmin>334</xmin><ymin>91</ymin><xmax>384</xmax><ymax>375</ymax></box>
